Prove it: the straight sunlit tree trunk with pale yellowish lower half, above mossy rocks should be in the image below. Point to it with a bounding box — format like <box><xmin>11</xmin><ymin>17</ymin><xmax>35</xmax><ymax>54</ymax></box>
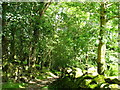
<box><xmin>97</xmin><ymin>2</ymin><xmax>106</xmax><ymax>75</ymax></box>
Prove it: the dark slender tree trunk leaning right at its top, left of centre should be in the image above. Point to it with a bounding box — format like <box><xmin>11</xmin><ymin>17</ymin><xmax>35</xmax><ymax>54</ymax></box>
<box><xmin>29</xmin><ymin>2</ymin><xmax>51</xmax><ymax>68</ymax></box>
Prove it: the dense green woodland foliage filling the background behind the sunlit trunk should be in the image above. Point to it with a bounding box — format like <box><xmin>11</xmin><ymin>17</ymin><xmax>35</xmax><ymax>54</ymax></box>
<box><xmin>2</xmin><ymin>2</ymin><xmax>120</xmax><ymax>88</ymax></box>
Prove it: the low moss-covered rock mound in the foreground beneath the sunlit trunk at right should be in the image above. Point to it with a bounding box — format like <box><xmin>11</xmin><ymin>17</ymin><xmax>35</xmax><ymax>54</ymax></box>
<box><xmin>48</xmin><ymin>71</ymin><xmax>118</xmax><ymax>90</ymax></box>
